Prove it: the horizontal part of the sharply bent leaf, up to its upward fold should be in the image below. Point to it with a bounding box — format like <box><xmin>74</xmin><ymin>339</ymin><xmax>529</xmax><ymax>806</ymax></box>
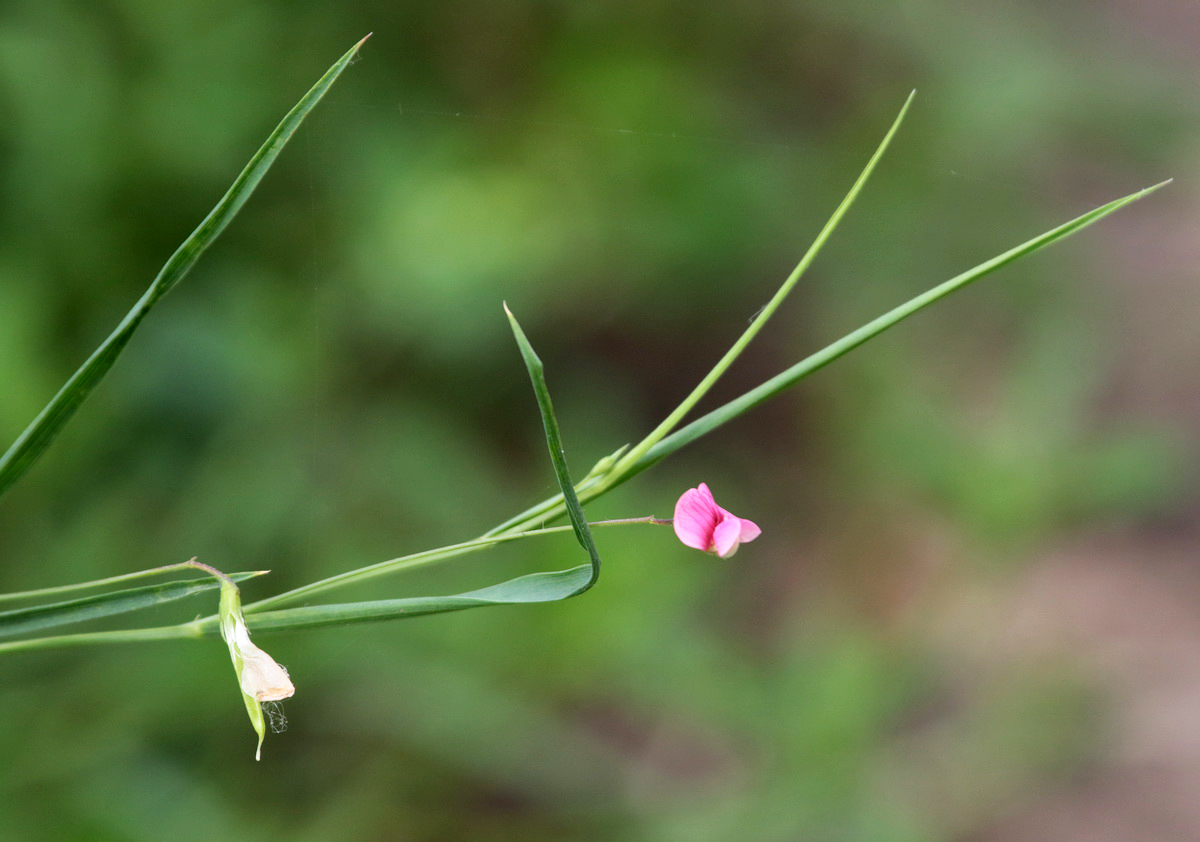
<box><xmin>241</xmin><ymin>564</ymin><xmax>595</xmax><ymax>632</ymax></box>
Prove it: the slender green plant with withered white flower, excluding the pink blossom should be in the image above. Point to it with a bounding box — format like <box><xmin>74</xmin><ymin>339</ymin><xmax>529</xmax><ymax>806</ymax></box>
<box><xmin>0</xmin><ymin>38</ymin><xmax>1166</xmax><ymax>758</ymax></box>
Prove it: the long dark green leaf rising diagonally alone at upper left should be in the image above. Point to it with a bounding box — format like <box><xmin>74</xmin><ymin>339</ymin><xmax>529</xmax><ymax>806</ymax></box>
<box><xmin>0</xmin><ymin>36</ymin><xmax>371</xmax><ymax>494</ymax></box>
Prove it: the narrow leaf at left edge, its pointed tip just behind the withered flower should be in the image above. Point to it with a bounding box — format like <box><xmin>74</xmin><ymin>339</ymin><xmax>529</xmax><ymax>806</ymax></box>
<box><xmin>0</xmin><ymin>571</ymin><xmax>264</xmax><ymax>637</ymax></box>
